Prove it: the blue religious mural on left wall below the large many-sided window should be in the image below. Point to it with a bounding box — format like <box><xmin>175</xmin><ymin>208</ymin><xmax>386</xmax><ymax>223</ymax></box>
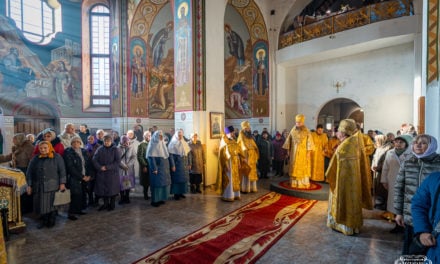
<box><xmin>0</xmin><ymin>7</ymin><xmax>82</xmax><ymax>116</ymax></box>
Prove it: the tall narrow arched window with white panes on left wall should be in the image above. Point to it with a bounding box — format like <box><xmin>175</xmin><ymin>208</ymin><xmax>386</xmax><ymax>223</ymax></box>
<box><xmin>90</xmin><ymin>5</ymin><xmax>110</xmax><ymax>106</ymax></box>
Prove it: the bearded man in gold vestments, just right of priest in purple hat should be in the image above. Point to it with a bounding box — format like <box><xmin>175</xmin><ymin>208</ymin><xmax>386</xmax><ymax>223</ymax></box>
<box><xmin>237</xmin><ymin>121</ymin><xmax>260</xmax><ymax>193</ymax></box>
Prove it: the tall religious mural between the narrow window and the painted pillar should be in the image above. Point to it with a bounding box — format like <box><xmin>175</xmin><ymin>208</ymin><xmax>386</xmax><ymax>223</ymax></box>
<box><xmin>127</xmin><ymin>0</ymin><xmax>174</xmax><ymax>119</ymax></box>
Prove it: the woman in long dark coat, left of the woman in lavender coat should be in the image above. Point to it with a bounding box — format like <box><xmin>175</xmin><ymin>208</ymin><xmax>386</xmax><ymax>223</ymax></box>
<box><xmin>92</xmin><ymin>135</ymin><xmax>121</xmax><ymax>211</ymax></box>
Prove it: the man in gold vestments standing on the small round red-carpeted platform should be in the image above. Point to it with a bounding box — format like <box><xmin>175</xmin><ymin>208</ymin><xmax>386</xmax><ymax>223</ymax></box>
<box><xmin>283</xmin><ymin>114</ymin><xmax>314</xmax><ymax>189</ymax></box>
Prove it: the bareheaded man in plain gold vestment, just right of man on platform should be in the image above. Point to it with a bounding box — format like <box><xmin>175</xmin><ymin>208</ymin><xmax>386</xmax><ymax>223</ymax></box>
<box><xmin>310</xmin><ymin>124</ymin><xmax>328</xmax><ymax>181</ymax></box>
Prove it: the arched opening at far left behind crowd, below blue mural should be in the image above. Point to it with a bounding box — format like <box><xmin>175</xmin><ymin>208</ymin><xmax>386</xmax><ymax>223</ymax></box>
<box><xmin>14</xmin><ymin>99</ymin><xmax>59</xmax><ymax>135</ymax></box>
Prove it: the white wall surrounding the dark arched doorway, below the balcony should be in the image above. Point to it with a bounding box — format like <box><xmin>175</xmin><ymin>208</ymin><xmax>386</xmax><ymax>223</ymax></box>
<box><xmin>284</xmin><ymin>43</ymin><xmax>415</xmax><ymax>132</ymax></box>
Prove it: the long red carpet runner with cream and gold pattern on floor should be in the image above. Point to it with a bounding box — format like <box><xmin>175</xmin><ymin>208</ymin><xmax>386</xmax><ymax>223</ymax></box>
<box><xmin>134</xmin><ymin>192</ymin><xmax>316</xmax><ymax>264</ymax></box>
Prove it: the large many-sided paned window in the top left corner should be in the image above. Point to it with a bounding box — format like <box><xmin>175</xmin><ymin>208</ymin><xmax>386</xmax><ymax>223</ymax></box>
<box><xmin>6</xmin><ymin>0</ymin><xmax>62</xmax><ymax>44</ymax></box>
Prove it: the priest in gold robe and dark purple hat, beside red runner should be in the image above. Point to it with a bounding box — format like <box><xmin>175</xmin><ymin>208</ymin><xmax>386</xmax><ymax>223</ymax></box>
<box><xmin>216</xmin><ymin>126</ymin><xmax>244</xmax><ymax>202</ymax></box>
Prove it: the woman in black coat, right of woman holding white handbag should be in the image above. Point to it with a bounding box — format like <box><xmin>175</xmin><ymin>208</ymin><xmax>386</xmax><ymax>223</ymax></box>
<box><xmin>64</xmin><ymin>136</ymin><xmax>90</xmax><ymax>220</ymax></box>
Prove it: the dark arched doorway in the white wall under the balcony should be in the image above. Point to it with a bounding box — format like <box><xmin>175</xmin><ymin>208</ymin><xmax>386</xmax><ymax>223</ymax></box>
<box><xmin>318</xmin><ymin>98</ymin><xmax>364</xmax><ymax>131</ymax></box>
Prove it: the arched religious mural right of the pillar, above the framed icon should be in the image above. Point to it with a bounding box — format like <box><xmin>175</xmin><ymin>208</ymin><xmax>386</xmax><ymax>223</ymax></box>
<box><xmin>224</xmin><ymin>0</ymin><xmax>269</xmax><ymax>119</ymax></box>
